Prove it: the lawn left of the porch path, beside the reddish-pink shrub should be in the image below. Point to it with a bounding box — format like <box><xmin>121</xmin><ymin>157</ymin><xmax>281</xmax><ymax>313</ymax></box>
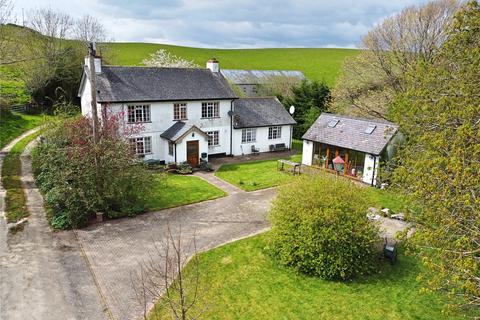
<box><xmin>147</xmin><ymin>174</ymin><xmax>227</xmax><ymax>211</ymax></box>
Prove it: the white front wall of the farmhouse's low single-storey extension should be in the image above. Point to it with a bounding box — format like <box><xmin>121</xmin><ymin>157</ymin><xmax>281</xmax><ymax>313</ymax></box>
<box><xmin>233</xmin><ymin>125</ymin><xmax>292</xmax><ymax>156</ymax></box>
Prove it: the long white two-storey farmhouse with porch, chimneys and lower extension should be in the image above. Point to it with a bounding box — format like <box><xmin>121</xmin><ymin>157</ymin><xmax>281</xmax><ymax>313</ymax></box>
<box><xmin>79</xmin><ymin>58</ymin><xmax>295</xmax><ymax>166</ymax></box>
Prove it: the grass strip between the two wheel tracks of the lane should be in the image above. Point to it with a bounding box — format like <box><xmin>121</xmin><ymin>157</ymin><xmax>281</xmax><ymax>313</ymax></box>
<box><xmin>2</xmin><ymin>131</ymin><xmax>41</xmax><ymax>222</ymax></box>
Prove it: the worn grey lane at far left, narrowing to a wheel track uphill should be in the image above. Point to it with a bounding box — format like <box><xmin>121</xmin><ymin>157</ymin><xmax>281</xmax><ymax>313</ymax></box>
<box><xmin>0</xmin><ymin>136</ymin><xmax>106</xmax><ymax>320</ymax></box>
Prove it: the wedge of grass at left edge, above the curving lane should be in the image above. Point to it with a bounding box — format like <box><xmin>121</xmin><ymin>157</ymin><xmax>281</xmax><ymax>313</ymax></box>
<box><xmin>0</xmin><ymin>113</ymin><xmax>48</xmax><ymax>148</ymax></box>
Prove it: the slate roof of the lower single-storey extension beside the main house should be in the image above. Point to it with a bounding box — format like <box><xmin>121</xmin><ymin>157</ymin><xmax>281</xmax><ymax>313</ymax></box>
<box><xmin>233</xmin><ymin>97</ymin><xmax>297</xmax><ymax>129</ymax></box>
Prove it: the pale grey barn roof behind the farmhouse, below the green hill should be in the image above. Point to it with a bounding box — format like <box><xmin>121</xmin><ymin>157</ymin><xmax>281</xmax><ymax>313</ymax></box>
<box><xmin>220</xmin><ymin>69</ymin><xmax>305</xmax><ymax>84</ymax></box>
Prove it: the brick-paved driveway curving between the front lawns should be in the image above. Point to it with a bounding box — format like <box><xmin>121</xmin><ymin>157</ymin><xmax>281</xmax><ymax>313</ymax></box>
<box><xmin>78</xmin><ymin>188</ymin><xmax>276</xmax><ymax>320</ymax></box>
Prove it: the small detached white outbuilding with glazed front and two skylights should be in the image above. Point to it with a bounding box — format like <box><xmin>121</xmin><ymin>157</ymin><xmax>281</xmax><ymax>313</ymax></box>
<box><xmin>302</xmin><ymin>113</ymin><xmax>402</xmax><ymax>185</ymax></box>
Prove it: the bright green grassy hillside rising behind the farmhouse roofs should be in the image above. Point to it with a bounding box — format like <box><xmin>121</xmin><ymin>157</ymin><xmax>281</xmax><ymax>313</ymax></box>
<box><xmin>109</xmin><ymin>42</ymin><xmax>359</xmax><ymax>85</ymax></box>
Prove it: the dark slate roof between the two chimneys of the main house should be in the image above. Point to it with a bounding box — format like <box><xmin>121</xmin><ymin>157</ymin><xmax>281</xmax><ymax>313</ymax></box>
<box><xmin>90</xmin><ymin>66</ymin><xmax>237</xmax><ymax>102</ymax></box>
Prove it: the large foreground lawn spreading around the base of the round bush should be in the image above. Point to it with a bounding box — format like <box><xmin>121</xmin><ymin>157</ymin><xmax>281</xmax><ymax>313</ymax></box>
<box><xmin>152</xmin><ymin>234</ymin><xmax>460</xmax><ymax>320</ymax></box>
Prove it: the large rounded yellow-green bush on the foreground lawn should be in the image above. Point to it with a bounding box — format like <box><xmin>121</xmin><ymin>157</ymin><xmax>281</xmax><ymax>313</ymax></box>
<box><xmin>269</xmin><ymin>174</ymin><xmax>380</xmax><ymax>279</ymax></box>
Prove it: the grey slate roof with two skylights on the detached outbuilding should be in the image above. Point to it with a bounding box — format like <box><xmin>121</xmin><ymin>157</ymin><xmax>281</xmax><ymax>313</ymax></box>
<box><xmin>302</xmin><ymin>113</ymin><xmax>398</xmax><ymax>155</ymax></box>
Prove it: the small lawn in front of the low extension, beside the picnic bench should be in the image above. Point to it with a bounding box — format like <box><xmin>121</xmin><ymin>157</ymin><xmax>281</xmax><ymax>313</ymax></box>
<box><xmin>215</xmin><ymin>159</ymin><xmax>298</xmax><ymax>191</ymax></box>
